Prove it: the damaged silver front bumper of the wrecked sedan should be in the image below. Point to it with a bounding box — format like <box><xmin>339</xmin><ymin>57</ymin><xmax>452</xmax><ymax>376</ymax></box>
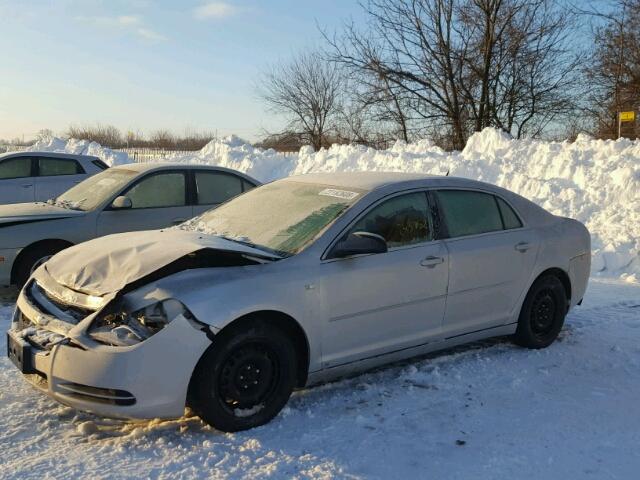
<box><xmin>10</xmin><ymin>316</ymin><xmax>211</xmax><ymax>419</ymax></box>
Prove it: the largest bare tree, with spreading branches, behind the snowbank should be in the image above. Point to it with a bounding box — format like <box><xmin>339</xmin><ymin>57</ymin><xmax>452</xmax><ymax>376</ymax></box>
<box><xmin>328</xmin><ymin>0</ymin><xmax>580</xmax><ymax>149</ymax></box>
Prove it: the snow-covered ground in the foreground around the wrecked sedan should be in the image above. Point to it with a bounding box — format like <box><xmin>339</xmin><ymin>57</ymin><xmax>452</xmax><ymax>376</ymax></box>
<box><xmin>0</xmin><ymin>279</ymin><xmax>640</xmax><ymax>480</ymax></box>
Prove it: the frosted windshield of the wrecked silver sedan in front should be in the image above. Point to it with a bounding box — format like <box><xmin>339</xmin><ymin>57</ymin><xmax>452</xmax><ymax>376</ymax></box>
<box><xmin>180</xmin><ymin>180</ymin><xmax>364</xmax><ymax>255</ymax></box>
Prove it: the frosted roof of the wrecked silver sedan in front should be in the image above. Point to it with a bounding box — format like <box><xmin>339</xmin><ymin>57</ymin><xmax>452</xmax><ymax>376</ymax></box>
<box><xmin>284</xmin><ymin>172</ymin><xmax>497</xmax><ymax>190</ymax></box>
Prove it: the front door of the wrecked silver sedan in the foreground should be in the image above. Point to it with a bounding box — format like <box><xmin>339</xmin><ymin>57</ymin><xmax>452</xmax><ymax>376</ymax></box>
<box><xmin>320</xmin><ymin>192</ymin><xmax>448</xmax><ymax>367</ymax></box>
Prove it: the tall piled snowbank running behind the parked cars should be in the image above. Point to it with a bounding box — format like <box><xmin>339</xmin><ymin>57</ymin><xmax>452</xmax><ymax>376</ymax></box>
<box><xmin>33</xmin><ymin>128</ymin><xmax>640</xmax><ymax>282</ymax></box>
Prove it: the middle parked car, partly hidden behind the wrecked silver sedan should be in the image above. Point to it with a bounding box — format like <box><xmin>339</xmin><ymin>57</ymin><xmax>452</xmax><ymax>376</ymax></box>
<box><xmin>0</xmin><ymin>163</ymin><xmax>258</xmax><ymax>286</ymax></box>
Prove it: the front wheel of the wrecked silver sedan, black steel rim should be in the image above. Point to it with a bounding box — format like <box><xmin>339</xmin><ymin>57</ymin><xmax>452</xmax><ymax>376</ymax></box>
<box><xmin>189</xmin><ymin>321</ymin><xmax>296</xmax><ymax>432</ymax></box>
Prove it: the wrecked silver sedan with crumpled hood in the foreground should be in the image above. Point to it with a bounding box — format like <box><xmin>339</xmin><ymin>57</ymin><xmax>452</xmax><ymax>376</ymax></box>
<box><xmin>8</xmin><ymin>173</ymin><xmax>590</xmax><ymax>431</ymax></box>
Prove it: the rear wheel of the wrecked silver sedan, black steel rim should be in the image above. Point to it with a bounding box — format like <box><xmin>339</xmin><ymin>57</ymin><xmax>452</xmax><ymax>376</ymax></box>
<box><xmin>514</xmin><ymin>275</ymin><xmax>567</xmax><ymax>348</ymax></box>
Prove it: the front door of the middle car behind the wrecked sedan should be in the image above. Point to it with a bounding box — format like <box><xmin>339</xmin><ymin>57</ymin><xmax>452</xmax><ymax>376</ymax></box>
<box><xmin>97</xmin><ymin>170</ymin><xmax>193</xmax><ymax>236</ymax></box>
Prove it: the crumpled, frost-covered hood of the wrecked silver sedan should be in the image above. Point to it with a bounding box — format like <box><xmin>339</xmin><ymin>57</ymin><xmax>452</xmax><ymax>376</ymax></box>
<box><xmin>43</xmin><ymin>229</ymin><xmax>279</xmax><ymax>296</ymax></box>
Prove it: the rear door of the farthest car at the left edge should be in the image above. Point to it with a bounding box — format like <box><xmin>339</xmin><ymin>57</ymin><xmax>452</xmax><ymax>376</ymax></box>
<box><xmin>35</xmin><ymin>157</ymin><xmax>87</xmax><ymax>202</ymax></box>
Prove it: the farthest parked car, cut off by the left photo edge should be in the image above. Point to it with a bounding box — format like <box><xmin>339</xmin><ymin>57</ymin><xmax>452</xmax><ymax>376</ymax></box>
<box><xmin>0</xmin><ymin>152</ymin><xmax>108</xmax><ymax>205</ymax></box>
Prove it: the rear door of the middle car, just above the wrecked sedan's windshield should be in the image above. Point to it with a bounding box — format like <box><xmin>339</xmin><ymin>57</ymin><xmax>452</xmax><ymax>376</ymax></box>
<box><xmin>193</xmin><ymin>170</ymin><xmax>254</xmax><ymax>215</ymax></box>
